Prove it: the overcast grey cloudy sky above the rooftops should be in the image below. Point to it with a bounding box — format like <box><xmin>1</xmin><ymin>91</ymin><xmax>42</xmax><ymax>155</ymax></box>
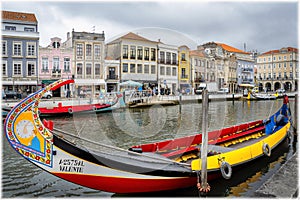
<box><xmin>2</xmin><ymin>1</ymin><xmax>298</xmax><ymax>52</ymax></box>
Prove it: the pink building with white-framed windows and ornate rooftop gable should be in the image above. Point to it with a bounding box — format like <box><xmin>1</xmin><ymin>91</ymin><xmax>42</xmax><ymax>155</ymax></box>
<box><xmin>39</xmin><ymin>37</ymin><xmax>73</xmax><ymax>97</ymax></box>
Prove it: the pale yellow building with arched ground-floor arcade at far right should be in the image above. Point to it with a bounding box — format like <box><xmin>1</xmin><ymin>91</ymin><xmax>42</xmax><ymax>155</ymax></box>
<box><xmin>256</xmin><ymin>47</ymin><xmax>299</xmax><ymax>91</ymax></box>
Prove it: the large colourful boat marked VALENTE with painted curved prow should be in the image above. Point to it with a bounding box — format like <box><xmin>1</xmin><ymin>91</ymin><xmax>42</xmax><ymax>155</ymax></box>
<box><xmin>4</xmin><ymin>81</ymin><xmax>291</xmax><ymax>193</ymax></box>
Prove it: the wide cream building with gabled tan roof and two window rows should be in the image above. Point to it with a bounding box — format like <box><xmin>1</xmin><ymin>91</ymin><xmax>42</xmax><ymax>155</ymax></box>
<box><xmin>106</xmin><ymin>32</ymin><xmax>157</xmax><ymax>88</ymax></box>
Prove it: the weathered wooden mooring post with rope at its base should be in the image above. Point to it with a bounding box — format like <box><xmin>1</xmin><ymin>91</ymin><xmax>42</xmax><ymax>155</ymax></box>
<box><xmin>201</xmin><ymin>90</ymin><xmax>209</xmax><ymax>192</ymax></box>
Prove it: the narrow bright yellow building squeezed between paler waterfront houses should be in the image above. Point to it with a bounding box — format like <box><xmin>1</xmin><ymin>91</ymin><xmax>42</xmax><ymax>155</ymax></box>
<box><xmin>178</xmin><ymin>45</ymin><xmax>192</xmax><ymax>94</ymax></box>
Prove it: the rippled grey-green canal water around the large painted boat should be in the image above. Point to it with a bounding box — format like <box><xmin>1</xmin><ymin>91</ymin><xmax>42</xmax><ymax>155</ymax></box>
<box><xmin>2</xmin><ymin>99</ymin><xmax>297</xmax><ymax>198</ymax></box>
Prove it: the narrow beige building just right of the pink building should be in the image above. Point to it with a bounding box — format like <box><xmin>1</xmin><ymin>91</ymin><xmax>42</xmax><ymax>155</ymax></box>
<box><xmin>63</xmin><ymin>30</ymin><xmax>106</xmax><ymax>97</ymax></box>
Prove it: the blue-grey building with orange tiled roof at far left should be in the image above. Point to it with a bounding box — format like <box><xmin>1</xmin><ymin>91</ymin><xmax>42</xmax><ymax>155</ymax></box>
<box><xmin>2</xmin><ymin>11</ymin><xmax>39</xmax><ymax>95</ymax></box>
